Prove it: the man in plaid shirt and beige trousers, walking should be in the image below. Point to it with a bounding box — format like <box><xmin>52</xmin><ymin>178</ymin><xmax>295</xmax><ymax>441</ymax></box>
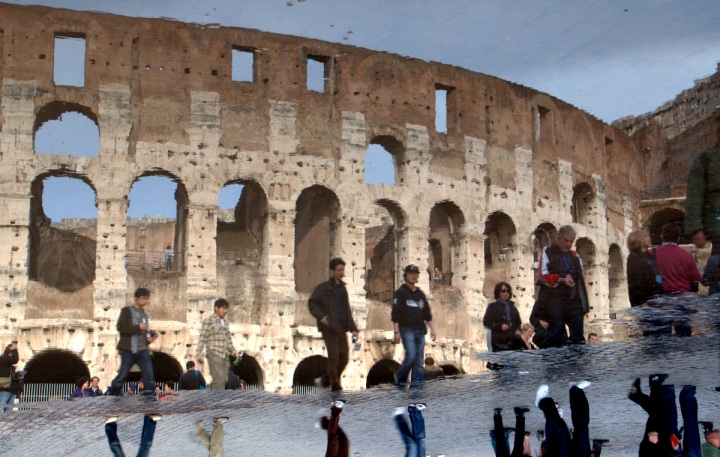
<box><xmin>195</xmin><ymin>298</ymin><xmax>240</xmax><ymax>390</ymax></box>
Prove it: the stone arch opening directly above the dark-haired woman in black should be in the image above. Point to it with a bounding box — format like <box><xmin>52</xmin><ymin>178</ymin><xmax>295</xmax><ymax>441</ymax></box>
<box><xmin>483</xmin><ymin>211</ymin><xmax>517</xmax><ymax>300</ymax></box>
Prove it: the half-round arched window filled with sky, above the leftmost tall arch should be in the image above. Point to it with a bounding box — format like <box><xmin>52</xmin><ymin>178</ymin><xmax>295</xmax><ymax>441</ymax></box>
<box><xmin>34</xmin><ymin>102</ymin><xmax>100</xmax><ymax>157</ymax></box>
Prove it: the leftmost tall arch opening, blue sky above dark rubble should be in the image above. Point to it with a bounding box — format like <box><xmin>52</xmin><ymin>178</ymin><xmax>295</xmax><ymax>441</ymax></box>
<box><xmin>28</xmin><ymin>172</ymin><xmax>97</xmax><ymax>292</ymax></box>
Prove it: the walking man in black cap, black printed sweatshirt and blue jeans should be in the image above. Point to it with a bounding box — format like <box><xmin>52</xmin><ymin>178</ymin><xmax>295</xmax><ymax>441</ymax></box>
<box><xmin>390</xmin><ymin>264</ymin><xmax>437</xmax><ymax>386</ymax></box>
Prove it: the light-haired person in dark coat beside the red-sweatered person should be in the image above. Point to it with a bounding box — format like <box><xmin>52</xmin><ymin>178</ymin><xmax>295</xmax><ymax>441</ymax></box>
<box><xmin>626</xmin><ymin>230</ymin><xmax>662</xmax><ymax>306</ymax></box>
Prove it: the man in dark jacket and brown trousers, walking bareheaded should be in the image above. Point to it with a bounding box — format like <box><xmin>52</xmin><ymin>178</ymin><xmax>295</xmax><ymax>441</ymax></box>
<box><xmin>308</xmin><ymin>258</ymin><xmax>358</xmax><ymax>391</ymax></box>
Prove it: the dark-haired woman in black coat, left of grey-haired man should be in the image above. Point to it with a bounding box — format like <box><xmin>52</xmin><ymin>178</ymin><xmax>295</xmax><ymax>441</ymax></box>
<box><xmin>483</xmin><ymin>282</ymin><xmax>522</xmax><ymax>352</ymax></box>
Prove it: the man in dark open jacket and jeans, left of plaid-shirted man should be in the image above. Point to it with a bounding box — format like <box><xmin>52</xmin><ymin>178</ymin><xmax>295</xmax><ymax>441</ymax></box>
<box><xmin>110</xmin><ymin>288</ymin><xmax>155</xmax><ymax>396</ymax></box>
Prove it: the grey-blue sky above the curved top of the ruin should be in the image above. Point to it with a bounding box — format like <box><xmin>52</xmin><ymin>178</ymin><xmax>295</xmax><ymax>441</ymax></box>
<box><xmin>18</xmin><ymin>0</ymin><xmax>720</xmax><ymax>220</ymax></box>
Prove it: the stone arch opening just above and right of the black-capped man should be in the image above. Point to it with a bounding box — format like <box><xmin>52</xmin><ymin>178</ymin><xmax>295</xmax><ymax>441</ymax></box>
<box><xmin>428</xmin><ymin>200</ymin><xmax>465</xmax><ymax>286</ymax></box>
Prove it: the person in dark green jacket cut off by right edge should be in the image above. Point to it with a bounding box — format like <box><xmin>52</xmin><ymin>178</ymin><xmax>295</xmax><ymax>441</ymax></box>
<box><xmin>685</xmin><ymin>124</ymin><xmax>720</xmax><ymax>250</ymax></box>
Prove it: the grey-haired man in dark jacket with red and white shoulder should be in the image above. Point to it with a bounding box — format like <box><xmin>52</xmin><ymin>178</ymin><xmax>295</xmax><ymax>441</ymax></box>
<box><xmin>540</xmin><ymin>225</ymin><xmax>589</xmax><ymax>347</ymax></box>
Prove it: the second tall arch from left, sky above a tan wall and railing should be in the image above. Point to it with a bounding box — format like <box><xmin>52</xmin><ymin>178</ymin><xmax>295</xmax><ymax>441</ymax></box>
<box><xmin>127</xmin><ymin>171</ymin><xmax>188</xmax><ymax>271</ymax></box>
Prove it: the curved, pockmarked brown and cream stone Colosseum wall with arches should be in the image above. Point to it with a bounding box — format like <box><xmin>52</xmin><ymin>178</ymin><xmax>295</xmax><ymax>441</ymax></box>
<box><xmin>0</xmin><ymin>4</ymin><xmax>644</xmax><ymax>392</ymax></box>
